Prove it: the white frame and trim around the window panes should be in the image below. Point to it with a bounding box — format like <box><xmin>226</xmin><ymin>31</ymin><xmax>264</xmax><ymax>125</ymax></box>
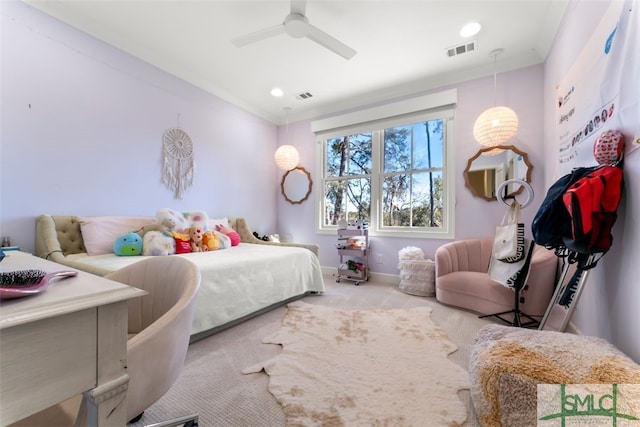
<box><xmin>311</xmin><ymin>89</ymin><xmax>457</xmax><ymax>239</ymax></box>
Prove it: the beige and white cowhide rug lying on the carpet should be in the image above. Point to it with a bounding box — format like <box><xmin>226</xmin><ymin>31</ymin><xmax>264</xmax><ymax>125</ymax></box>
<box><xmin>244</xmin><ymin>300</ymin><xmax>469</xmax><ymax>426</ymax></box>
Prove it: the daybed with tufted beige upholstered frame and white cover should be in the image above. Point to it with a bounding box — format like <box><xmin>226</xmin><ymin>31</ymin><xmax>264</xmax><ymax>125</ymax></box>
<box><xmin>36</xmin><ymin>215</ymin><xmax>324</xmax><ymax>342</ymax></box>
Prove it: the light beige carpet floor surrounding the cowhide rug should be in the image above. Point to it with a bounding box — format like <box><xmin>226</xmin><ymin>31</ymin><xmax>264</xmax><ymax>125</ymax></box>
<box><xmin>130</xmin><ymin>275</ymin><xmax>494</xmax><ymax>427</ymax></box>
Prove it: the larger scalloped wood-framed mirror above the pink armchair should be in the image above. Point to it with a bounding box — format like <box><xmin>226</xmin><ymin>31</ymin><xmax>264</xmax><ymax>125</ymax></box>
<box><xmin>464</xmin><ymin>145</ymin><xmax>533</xmax><ymax>201</ymax></box>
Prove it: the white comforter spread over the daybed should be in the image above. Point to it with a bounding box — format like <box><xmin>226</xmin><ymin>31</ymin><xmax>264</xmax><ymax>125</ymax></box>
<box><xmin>69</xmin><ymin>243</ymin><xmax>324</xmax><ymax>335</ymax></box>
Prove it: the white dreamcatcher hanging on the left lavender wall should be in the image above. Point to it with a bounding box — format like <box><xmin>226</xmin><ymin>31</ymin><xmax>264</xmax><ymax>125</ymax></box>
<box><xmin>162</xmin><ymin>124</ymin><xmax>195</xmax><ymax>199</ymax></box>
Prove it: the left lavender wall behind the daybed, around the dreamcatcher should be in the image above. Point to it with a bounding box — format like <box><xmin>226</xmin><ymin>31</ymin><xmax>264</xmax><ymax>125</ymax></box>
<box><xmin>0</xmin><ymin>2</ymin><xmax>278</xmax><ymax>251</ymax></box>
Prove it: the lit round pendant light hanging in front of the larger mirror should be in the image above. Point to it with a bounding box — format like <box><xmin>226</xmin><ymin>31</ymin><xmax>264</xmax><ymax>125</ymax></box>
<box><xmin>473</xmin><ymin>49</ymin><xmax>518</xmax><ymax>147</ymax></box>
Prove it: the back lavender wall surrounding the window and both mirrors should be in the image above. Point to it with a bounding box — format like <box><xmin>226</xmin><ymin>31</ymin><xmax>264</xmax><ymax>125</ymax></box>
<box><xmin>278</xmin><ymin>65</ymin><xmax>545</xmax><ymax>275</ymax></box>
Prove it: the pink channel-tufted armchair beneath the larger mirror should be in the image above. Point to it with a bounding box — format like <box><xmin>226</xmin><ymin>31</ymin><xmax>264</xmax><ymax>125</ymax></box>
<box><xmin>435</xmin><ymin>238</ymin><xmax>558</xmax><ymax>320</ymax></box>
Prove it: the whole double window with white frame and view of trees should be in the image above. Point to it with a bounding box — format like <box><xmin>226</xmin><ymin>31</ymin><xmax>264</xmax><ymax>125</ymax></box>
<box><xmin>316</xmin><ymin>90</ymin><xmax>454</xmax><ymax>238</ymax></box>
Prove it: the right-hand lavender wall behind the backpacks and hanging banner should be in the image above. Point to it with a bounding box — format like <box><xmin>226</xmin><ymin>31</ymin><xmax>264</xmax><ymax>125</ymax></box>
<box><xmin>544</xmin><ymin>0</ymin><xmax>640</xmax><ymax>362</ymax></box>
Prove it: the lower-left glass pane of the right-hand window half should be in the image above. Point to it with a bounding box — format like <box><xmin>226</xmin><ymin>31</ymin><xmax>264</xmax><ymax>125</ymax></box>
<box><xmin>382</xmin><ymin>174</ymin><xmax>411</xmax><ymax>227</ymax></box>
